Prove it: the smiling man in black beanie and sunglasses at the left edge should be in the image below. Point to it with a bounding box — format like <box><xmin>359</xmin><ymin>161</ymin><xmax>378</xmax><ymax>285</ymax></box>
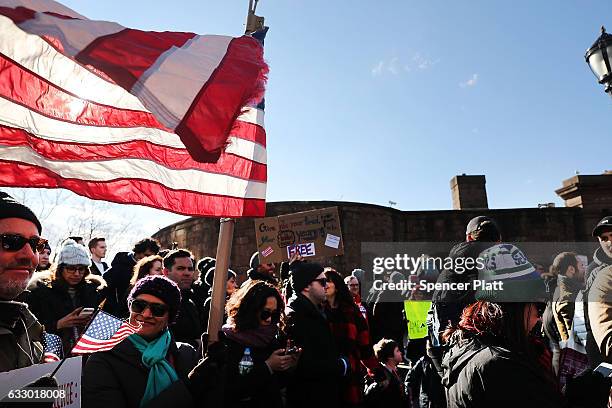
<box><xmin>0</xmin><ymin>192</ymin><xmax>46</xmax><ymax>372</ymax></box>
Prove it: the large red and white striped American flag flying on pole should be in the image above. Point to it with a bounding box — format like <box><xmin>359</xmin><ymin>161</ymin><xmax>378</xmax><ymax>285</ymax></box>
<box><xmin>0</xmin><ymin>0</ymin><xmax>268</xmax><ymax>217</ymax></box>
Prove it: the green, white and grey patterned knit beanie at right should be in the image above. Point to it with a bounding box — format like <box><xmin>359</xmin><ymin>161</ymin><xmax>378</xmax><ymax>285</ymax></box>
<box><xmin>476</xmin><ymin>244</ymin><xmax>548</xmax><ymax>302</ymax></box>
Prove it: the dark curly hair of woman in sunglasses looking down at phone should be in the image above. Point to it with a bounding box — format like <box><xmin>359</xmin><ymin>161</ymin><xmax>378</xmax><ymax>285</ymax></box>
<box><xmin>225</xmin><ymin>280</ymin><xmax>285</xmax><ymax>331</ymax></box>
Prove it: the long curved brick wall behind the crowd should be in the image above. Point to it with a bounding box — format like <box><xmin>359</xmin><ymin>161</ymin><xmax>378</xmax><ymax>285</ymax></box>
<box><xmin>154</xmin><ymin>201</ymin><xmax>612</xmax><ymax>273</ymax></box>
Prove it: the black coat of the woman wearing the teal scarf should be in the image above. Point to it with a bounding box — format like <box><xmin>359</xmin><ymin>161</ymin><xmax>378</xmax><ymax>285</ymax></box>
<box><xmin>81</xmin><ymin>339</ymin><xmax>198</xmax><ymax>408</ymax></box>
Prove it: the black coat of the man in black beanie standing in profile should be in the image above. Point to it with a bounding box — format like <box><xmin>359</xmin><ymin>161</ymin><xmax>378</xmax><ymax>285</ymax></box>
<box><xmin>285</xmin><ymin>294</ymin><xmax>340</xmax><ymax>408</ymax></box>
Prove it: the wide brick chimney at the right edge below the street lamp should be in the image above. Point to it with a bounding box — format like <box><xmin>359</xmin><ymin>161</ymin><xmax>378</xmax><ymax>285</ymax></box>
<box><xmin>555</xmin><ymin>171</ymin><xmax>612</xmax><ymax>210</ymax></box>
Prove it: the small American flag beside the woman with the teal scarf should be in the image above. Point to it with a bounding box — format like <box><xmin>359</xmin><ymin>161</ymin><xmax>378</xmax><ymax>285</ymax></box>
<box><xmin>72</xmin><ymin>311</ymin><xmax>140</xmax><ymax>354</ymax></box>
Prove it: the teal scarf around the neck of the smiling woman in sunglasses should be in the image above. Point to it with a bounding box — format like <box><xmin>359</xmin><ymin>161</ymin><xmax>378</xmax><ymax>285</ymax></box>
<box><xmin>128</xmin><ymin>330</ymin><xmax>178</xmax><ymax>407</ymax></box>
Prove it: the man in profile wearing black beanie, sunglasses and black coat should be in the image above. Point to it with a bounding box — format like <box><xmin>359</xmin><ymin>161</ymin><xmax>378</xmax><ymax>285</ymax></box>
<box><xmin>286</xmin><ymin>261</ymin><xmax>349</xmax><ymax>407</ymax></box>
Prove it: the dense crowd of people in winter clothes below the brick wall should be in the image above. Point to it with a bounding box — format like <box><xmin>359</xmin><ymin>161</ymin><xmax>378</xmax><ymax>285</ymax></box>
<box><xmin>0</xmin><ymin>192</ymin><xmax>612</xmax><ymax>408</ymax></box>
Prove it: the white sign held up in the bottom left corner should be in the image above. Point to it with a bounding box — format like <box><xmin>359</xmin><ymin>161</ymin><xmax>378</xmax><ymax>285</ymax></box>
<box><xmin>0</xmin><ymin>356</ymin><xmax>83</xmax><ymax>408</ymax></box>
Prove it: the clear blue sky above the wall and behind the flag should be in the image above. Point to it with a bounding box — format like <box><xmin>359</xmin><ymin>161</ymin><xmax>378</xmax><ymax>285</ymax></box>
<box><xmin>10</xmin><ymin>0</ymin><xmax>612</xmax><ymax>249</ymax></box>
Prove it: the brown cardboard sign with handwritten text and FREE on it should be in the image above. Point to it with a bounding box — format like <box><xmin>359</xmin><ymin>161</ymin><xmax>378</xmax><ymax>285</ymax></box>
<box><xmin>255</xmin><ymin>207</ymin><xmax>344</xmax><ymax>263</ymax></box>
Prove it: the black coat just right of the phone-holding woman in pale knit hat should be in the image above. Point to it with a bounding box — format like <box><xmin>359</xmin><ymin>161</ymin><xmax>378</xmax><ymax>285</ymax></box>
<box><xmin>104</xmin><ymin>252</ymin><xmax>136</xmax><ymax>317</ymax></box>
